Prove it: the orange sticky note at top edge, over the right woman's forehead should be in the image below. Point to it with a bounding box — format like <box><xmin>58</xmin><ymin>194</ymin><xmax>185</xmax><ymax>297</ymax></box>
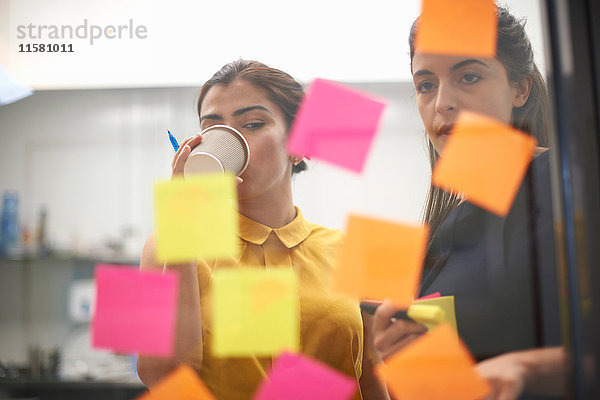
<box><xmin>415</xmin><ymin>0</ymin><xmax>498</xmax><ymax>57</ymax></box>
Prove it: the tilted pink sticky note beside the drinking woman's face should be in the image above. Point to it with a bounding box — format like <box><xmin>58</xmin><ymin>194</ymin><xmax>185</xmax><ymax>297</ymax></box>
<box><xmin>287</xmin><ymin>79</ymin><xmax>386</xmax><ymax>172</ymax></box>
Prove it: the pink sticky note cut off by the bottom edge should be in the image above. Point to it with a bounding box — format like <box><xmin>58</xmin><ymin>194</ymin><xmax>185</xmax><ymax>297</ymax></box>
<box><xmin>254</xmin><ymin>353</ymin><xmax>357</xmax><ymax>400</ymax></box>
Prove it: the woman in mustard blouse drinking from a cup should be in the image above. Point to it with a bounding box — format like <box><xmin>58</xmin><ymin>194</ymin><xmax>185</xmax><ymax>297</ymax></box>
<box><xmin>138</xmin><ymin>60</ymin><xmax>387</xmax><ymax>399</ymax></box>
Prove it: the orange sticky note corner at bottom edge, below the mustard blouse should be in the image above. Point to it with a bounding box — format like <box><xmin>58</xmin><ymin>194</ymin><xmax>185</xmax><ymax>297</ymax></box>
<box><xmin>137</xmin><ymin>364</ymin><xmax>215</xmax><ymax>400</ymax></box>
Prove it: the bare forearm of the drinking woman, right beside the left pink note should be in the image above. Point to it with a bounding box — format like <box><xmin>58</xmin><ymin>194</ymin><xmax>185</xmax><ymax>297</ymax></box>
<box><xmin>138</xmin><ymin>263</ymin><xmax>202</xmax><ymax>386</ymax></box>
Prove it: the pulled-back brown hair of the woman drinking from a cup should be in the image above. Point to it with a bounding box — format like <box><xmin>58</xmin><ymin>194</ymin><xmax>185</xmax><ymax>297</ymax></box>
<box><xmin>197</xmin><ymin>59</ymin><xmax>306</xmax><ymax>173</ymax></box>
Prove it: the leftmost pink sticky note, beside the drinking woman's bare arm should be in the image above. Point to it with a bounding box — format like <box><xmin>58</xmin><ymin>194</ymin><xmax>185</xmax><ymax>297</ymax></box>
<box><xmin>92</xmin><ymin>264</ymin><xmax>179</xmax><ymax>357</ymax></box>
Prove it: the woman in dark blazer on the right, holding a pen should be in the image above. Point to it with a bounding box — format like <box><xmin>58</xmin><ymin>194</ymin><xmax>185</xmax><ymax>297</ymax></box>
<box><xmin>374</xmin><ymin>7</ymin><xmax>564</xmax><ymax>399</ymax></box>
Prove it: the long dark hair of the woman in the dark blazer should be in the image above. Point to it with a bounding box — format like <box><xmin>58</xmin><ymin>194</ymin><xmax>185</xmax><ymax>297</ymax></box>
<box><xmin>408</xmin><ymin>7</ymin><xmax>550</xmax><ymax>244</ymax></box>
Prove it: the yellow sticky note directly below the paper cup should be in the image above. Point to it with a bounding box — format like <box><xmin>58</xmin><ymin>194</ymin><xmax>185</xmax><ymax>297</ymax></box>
<box><xmin>154</xmin><ymin>174</ymin><xmax>238</xmax><ymax>262</ymax></box>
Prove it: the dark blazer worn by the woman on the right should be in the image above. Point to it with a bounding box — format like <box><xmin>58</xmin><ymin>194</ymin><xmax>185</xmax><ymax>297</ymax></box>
<box><xmin>420</xmin><ymin>151</ymin><xmax>560</xmax><ymax>360</ymax></box>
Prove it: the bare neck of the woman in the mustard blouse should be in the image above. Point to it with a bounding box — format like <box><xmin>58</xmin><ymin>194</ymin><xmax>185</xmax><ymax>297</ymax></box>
<box><xmin>238</xmin><ymin>185</ymin><xmax>296</xmax><ymax>229</ymax></box>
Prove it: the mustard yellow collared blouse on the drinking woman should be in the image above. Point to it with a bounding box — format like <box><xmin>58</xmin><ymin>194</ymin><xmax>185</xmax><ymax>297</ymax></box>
<box><xmin>187</xmin><ymin>208</ymin><xmax>363</xmax><ymax>400</ymax></box>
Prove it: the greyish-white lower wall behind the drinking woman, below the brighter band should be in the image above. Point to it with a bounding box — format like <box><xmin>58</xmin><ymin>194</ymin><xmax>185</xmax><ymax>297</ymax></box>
<box><xmin>0</xmin><ymin>83</ymin><xmax>428</xmax><ymax>260</ymax></box>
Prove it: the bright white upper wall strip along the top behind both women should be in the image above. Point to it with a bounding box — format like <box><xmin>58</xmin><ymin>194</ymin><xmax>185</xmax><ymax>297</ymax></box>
<box><xmin>0</xmin><ymin>0</ymin><xmax>543</xmax><ymax>89</ymax></box>
